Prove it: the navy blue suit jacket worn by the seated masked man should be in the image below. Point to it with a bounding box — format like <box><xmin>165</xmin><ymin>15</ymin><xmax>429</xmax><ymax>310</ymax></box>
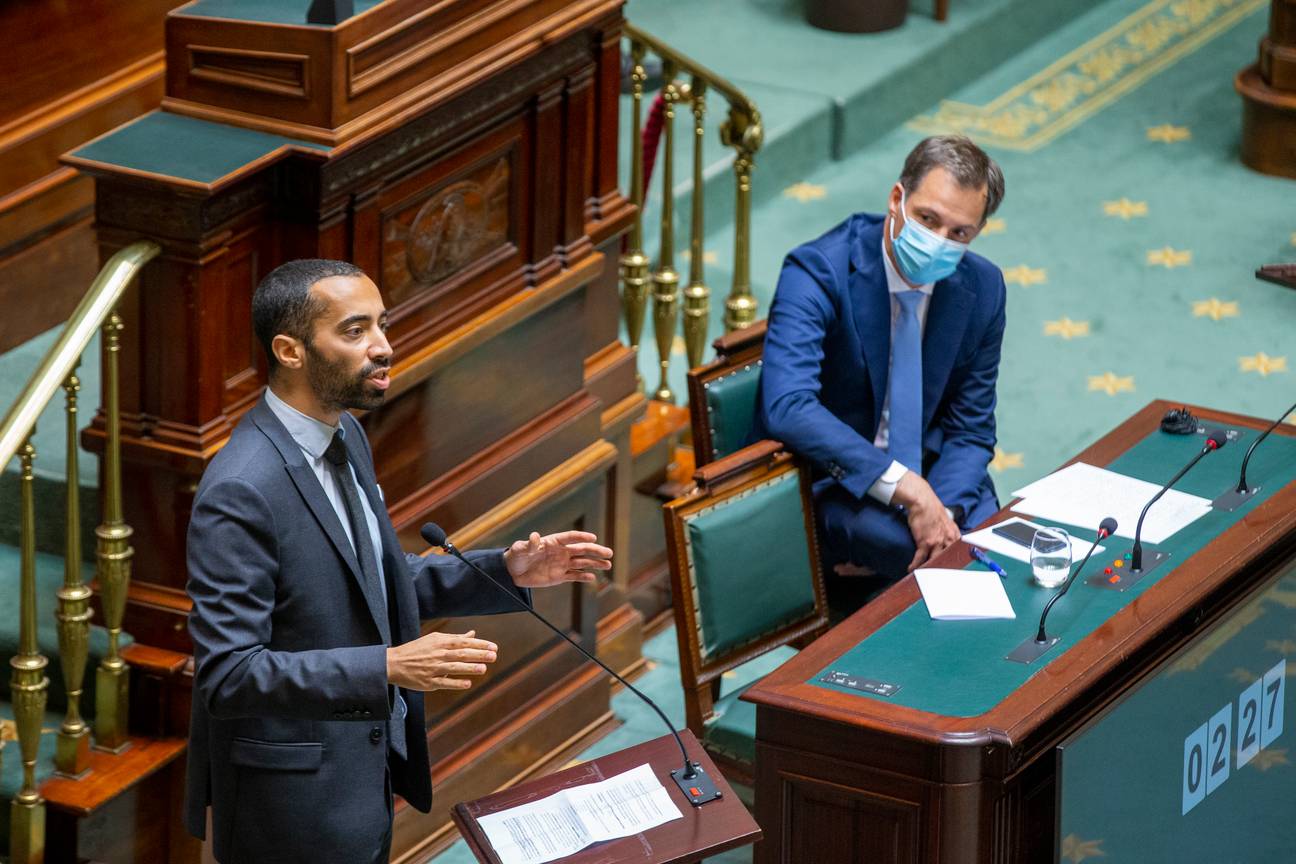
<box><xmin>756</xmin><ymin>214</ymin><xmax>1006</xmax><ymax>522</ymax></box>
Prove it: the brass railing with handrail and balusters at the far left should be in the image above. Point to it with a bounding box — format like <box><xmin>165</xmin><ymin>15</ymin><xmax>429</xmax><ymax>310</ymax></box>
<box><xmin>0</xmin><ymin>241</ymin><xmax>161</xmax><ymax>864</ymax></box>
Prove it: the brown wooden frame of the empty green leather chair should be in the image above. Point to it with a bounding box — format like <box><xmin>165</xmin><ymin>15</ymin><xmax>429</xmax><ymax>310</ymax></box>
<box><xmin>662</xmin><ymin>440</ymin><xmax>828</xmax><ymax>784</ymax></box>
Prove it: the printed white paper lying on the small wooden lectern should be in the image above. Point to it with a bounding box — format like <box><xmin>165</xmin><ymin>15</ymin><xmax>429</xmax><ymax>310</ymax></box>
<box><xmin>477</xmin><ymin>764</ymin><xmax>684</xmax><ymax>864</ymax></box>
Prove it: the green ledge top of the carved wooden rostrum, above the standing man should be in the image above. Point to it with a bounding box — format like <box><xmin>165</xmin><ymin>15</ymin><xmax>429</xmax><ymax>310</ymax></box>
<box><xmin>71</xmin><ymin>111</ymin><xmax>329</xmax><ymax>185</ymax></box>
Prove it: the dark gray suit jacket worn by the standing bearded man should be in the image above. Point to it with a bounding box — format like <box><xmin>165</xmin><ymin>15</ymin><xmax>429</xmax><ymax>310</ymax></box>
<box><xmin>185</xmin><ymin>400</ymin><xmax>530</xmax><ymax>864</ymax></box>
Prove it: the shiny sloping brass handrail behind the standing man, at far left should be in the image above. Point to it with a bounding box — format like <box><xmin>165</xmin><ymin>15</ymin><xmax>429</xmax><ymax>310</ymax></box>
<box><xmin>0</xmin><ymin>240</ymin><xmax>162</xmax><ymax>472</ymax></box>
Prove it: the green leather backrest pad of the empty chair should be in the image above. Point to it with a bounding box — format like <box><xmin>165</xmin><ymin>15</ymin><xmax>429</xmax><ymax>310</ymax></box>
<box><xmin>684</xmin><ymin>466</ymin><xmax>815</xmax><ymax>662</ymax></box>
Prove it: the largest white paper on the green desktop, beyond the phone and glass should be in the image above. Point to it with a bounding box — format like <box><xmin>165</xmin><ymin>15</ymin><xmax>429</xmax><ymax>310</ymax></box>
<box><xmin>1012</xmin><ymin>462</ymin><xmax>1210</xmax><ymax>543</ymax></box>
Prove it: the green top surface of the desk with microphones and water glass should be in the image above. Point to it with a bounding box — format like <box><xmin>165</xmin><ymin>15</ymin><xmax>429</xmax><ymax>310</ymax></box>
<box><xmin>807</xmin><ymin>430</ymin><xmax>1296</xmax><ymax>718</ymax></box>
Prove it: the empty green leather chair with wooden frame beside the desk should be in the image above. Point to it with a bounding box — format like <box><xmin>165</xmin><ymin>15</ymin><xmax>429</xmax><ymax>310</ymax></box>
<box><xmin>664</xmin><ymin>442</ymin><xmax>828</xmax><ymax>785</ymax></box>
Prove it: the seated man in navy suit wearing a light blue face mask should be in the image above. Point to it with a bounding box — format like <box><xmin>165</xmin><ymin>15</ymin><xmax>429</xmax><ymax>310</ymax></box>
<box><xmin>756</xmin><ymin>136</ymin><xmax>1006</xmax><ymax>588</ymax></box>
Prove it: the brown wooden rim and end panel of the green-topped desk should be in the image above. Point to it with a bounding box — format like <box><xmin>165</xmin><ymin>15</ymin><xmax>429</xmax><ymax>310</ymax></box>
<box><xmin>744</xmin><ymin>402</ymin><xmax>1296</xmax><ymax>864</ymax></box>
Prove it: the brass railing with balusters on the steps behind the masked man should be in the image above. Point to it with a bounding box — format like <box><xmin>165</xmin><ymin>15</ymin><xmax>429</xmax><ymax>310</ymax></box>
<box><xmin>621</xmin><ymin>25</ymin><xmax>763</xmax><ymax>403</ymax></box>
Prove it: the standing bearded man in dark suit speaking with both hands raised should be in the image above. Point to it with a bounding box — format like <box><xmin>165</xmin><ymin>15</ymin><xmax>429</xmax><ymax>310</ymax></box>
<box><xmin>185</xmin><ymin>260</ymin><xmax>612</xmax><ymax>864</ymax></box>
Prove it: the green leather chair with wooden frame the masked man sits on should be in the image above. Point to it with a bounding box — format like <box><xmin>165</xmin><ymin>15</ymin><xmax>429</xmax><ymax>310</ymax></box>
<box><xmin>688</xmin><ymin>321</ymin><xmax>765</xmax><ymax>468</ymax></box>
